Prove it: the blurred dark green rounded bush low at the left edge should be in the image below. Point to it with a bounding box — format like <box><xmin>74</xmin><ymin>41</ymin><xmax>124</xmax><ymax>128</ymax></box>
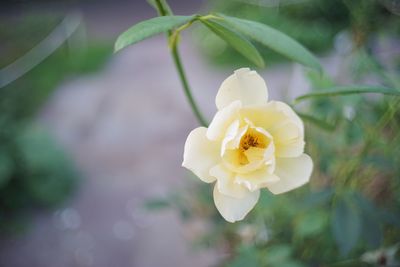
<box><xmin>0</xmin><ymin>123</ymin><xmax>78</xmax><ymax>233</ymax></box>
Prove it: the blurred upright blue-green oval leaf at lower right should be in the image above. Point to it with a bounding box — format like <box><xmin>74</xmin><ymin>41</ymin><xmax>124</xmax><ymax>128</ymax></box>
<box><xmin>331</xmin><ymin>198</ymin><xmax>361</xmax><ymax>255</ymax></box>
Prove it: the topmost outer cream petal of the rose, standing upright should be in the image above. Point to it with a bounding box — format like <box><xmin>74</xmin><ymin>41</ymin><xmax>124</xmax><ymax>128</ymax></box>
<box><xmin>215</xmin><ymin>68</ymin><xmax>268</xmax><ymax>110</ymax></box>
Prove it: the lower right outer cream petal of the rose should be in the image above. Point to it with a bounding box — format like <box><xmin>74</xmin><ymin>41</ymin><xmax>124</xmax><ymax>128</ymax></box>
<box><xmin>268</xmin><ymin>154</ymin><xmax>313</xmax><ymax>194</ymax></box>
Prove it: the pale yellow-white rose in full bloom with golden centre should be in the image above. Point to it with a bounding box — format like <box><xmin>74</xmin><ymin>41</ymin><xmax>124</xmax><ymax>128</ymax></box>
<box><xmin>182</xmin><ymin>68</ymin><xmax>313</xmax><ymax>222</ymax></box>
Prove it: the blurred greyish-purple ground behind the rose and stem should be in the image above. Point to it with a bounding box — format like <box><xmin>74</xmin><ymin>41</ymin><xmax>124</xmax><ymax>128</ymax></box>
<box><xmin>0</xmin><ymin>1</ymin><xmax>324</xmax><ymax>267</ymax></box>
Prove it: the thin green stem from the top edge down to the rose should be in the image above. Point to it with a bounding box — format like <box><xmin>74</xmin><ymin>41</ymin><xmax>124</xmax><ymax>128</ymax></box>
<box><xmin>155</xmin><ymin>0</ymin><xmax>208</xmax><ymax>127</ymax></box>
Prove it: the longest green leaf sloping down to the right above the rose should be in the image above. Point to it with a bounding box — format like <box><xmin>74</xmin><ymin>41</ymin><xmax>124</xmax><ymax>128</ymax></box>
<box><xmin>218</xmin><ymin>14</ymin><xmax>322</xmax><ymax>72</ymax></box>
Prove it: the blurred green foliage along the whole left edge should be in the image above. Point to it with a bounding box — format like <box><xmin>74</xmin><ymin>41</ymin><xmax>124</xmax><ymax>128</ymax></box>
<box><xmin>0</xmin><ymin>14</ymin><xmax>112</xmax><ymax>233</ymax></box>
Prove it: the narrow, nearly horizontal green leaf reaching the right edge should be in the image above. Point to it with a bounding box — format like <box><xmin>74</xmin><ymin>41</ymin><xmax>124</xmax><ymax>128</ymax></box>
<box><xmin>295</xmin><ymin>85</ymin><xmax>400</xmax><ymax>102</ymax></box>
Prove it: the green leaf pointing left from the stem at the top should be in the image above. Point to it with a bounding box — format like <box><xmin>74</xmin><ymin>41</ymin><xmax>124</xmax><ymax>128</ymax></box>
<box><xmin>114</xmin><ymin>16</ymin><xmax>194</xmax><ymax>52</ymax></box>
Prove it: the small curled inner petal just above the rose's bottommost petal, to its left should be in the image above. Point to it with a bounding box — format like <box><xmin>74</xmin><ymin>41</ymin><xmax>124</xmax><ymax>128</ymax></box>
<box><xmin>210</xmin><ymin>164</ymin><xmax>249</xmax><ymax>198</ymax></box>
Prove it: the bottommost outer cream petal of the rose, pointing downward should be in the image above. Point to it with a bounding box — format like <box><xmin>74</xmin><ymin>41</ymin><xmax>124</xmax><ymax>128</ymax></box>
<box><xmin>214</xmin><ymin>185</ymin><xmax>260</xmax><ymax>223</ymax></box>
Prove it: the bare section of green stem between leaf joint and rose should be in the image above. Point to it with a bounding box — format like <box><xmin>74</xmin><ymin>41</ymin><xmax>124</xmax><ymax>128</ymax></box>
<box><xmin>171</xmin><ymin>45</ymin><xmax>208</xmax><ymax>127</ymax></box>
